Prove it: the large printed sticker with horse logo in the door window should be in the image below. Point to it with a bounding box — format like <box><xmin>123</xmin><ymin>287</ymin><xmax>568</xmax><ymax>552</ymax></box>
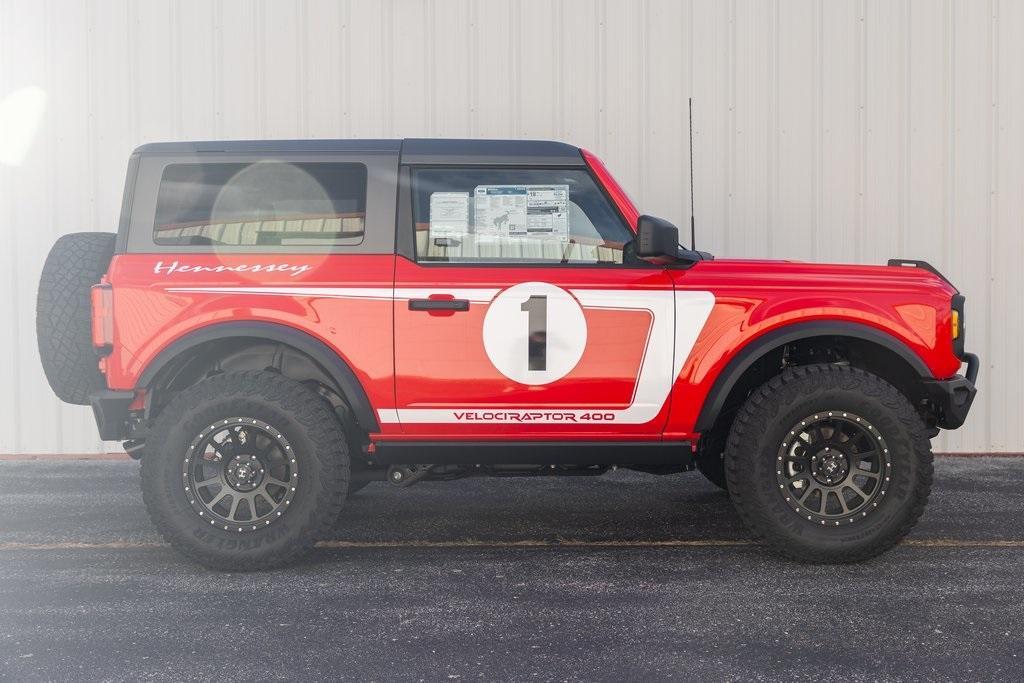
<box><xmin>473</xmin><ymin>185</ymin><xmax>569</xmax><ymax>243</ymax></box>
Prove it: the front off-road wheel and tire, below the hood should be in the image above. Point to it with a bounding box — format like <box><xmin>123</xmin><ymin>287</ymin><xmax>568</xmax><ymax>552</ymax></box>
<box><xmin>725</xmin><ymin>365</ymin><xmax>932</xmax><ymax>563</ymax></box>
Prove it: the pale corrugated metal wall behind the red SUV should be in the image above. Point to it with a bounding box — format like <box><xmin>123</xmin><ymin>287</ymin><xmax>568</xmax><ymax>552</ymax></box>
<box><xmin>0</xmin><ymin>0</ymin><xmax>1024</xmax><ymax>453</ymax></box>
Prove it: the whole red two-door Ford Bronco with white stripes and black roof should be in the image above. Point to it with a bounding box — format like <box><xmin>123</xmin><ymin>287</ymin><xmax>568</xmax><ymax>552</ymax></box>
<box><xmin>38</xmin><ymin>139</ymin><xmax>978</xmax><ymax>569</ymax></box>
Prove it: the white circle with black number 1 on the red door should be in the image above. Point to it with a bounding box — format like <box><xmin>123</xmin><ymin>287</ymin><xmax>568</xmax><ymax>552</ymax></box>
<box><xmin>483</xmin><ymin>283</ymin><xmax>587</xmax><ymax>385</ymax></box>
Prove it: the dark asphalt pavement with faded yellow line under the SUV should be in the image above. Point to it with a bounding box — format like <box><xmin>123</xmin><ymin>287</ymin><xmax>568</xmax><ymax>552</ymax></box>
<box><xmin>0</xmin><ymin>458</ymin><xmax>1024</xmax><ymax>681</ymax></box>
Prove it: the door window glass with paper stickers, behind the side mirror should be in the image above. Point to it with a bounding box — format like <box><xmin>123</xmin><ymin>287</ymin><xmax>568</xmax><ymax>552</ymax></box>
<box><xmin>413</xmin><ymin>168</ymin><xmax>633</xmax><ymax>265</ymax></box>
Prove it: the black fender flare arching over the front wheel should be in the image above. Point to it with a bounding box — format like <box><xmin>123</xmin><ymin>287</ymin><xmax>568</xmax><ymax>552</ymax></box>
<box><xmin>693</xmin><ymin>321</ymin><xmax>932</xmax><ymax>432</ymax></box>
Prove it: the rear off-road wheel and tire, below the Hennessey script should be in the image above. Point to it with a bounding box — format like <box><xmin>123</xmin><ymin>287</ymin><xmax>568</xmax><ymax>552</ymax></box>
<box><xmin>142</xmin><ymin>372</ymin><xmax>349</xmax><ymax>571</ymax></box>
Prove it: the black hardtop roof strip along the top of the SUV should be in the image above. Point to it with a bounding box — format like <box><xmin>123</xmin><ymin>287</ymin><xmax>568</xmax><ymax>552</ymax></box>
<box><xmin>133</xmin><ymin>137</ymin><xmax>584</xmax><ymax>166</ymax></box>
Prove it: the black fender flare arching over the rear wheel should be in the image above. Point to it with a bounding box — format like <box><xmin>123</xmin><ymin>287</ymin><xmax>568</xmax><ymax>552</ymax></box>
<box><xmin>136</xmin><ymin>322</ymin><xmax>380</xmax><ymax>432</ymax></box>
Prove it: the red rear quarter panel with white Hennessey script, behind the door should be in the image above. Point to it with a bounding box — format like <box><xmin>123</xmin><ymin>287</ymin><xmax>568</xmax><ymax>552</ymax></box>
<box><xmin>99</xmin><ymin>254</ymin><xmax>394</xmax><ymax>432</ymax></box>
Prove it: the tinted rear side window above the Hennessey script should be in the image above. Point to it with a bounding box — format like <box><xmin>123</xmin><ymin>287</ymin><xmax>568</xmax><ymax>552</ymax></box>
<box><xmin>153</xmin><ymin>161</ymin><xmax>367</xmax><ymax>248</ymax></box>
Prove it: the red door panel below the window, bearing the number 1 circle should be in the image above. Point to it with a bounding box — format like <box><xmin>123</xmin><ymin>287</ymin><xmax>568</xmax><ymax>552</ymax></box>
<box><xmin>391</xmin><ymin>258</ymin><xmax>674</xmax><ymax>439</ymax></box>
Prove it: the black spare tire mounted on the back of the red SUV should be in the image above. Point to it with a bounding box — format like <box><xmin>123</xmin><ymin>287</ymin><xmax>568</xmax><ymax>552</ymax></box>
<box><xmin>36</xmin><ymin>232</ymin><xmax>117</xmax><ymax>405</ymax></box>
